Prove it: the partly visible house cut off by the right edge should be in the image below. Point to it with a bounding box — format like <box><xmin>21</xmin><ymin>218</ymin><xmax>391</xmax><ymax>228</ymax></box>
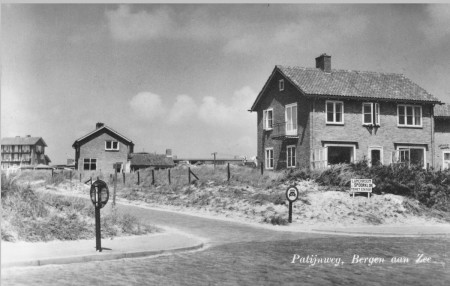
<box><xmin>434</xmin><ymin>104</ymin><xmax>450</xmax><ymax>169</ymax></box>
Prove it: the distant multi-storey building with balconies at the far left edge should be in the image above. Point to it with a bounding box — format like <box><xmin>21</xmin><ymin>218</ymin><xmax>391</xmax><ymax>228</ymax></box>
<box><xmin>1</xmin><ymin>135</ymin><xmax>51</xmax><ymax>169</ymax></box>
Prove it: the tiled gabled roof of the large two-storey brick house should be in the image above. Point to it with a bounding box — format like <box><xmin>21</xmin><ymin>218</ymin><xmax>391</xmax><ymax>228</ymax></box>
<box><xmin>251</xmin><ymin>65</ymin><xmax>440</xmax><ymax>111</ymax></box>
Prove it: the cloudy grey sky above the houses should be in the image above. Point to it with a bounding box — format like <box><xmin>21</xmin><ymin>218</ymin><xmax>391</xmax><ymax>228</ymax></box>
<box><xmin>1</xmin><ymin>4</ymin><xmax>450</xmax><ymax>164</ymax></box>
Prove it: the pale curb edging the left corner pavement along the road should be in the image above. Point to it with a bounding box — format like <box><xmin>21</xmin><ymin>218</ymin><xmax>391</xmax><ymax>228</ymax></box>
<box><xmin>2</xmin><ymin>243</ymin><xmax>204</xmax><ymax>268</ymax></box>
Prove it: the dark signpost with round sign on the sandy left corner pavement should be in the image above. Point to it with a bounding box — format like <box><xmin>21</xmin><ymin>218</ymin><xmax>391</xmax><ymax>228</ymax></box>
<box><xmin>91</xmin><ymin>180</ymin><xmax>109</xmax><ymax>252</ymax></box>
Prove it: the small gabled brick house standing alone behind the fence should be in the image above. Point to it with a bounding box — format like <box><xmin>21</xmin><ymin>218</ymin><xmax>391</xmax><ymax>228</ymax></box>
<box><xmin>72</xmin><ymin>123</ymin><xmax>134</xmax><ymax>173</ymax></box>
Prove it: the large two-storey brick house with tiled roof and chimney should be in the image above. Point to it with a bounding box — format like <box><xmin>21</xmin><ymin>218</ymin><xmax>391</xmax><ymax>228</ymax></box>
<box><xmin>249</xmin><ymin>54</ymin><xmax>440</xmax><ymax>170</ymax></box>
